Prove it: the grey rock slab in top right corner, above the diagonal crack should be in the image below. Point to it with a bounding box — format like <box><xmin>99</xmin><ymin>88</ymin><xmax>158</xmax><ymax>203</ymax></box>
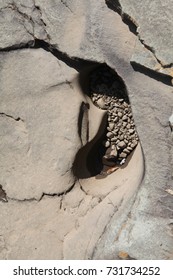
<box><xmin>119</xmin><ymin>0</ymin><xmax>173</xmax><ymax>66</ymax></box>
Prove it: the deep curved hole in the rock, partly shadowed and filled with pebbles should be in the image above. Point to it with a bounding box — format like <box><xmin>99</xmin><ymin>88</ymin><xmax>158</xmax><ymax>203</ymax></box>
<box><xmin>73</xmin><ymin>64</ymin><xmax>139</xmax><ymax>178</ymax></box>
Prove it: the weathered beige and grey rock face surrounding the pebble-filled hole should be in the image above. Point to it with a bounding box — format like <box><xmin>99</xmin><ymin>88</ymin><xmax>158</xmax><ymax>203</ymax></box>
<box><xmin>0</xmin><ymin>0</ymin><xmax>173</xmax><ymax>259</ymax></box>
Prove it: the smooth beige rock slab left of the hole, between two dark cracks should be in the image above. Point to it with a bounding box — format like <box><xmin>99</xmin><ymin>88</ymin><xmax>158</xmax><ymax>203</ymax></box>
<box><xmin>0</xmin><ymin>49</ymin><xmax>82</xmax><ymax>200</ymax></box>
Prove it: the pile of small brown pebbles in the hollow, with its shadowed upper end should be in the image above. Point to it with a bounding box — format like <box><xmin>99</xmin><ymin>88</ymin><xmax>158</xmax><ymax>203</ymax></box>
<box><xmin>90</xmin><ymin>66</ymin><xmax>139</xmax><ymax>166</ymax></box>
